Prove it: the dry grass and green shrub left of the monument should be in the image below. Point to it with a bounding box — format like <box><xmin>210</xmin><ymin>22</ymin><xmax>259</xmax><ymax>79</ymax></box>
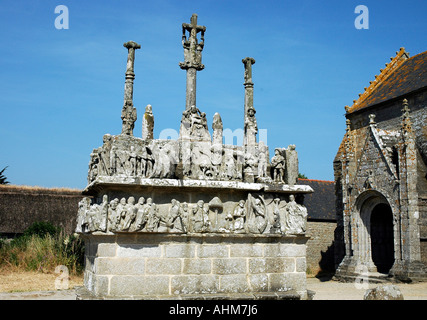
<box><xmin>0</xmin><ymin>222</ymin><xmax>84</xmax><ymax>292</ymax></box>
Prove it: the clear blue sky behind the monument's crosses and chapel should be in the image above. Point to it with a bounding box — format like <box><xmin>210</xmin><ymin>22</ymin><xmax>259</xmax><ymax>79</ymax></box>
<box><xmin>0</xmin><ymin>0</ymin><xmax>427</xmax><ymax>189</ymax></box>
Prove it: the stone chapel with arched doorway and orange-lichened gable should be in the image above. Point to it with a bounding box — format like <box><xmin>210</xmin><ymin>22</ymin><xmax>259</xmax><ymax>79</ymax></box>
<box><xmin>334</xmin><ymin>48</ymin><xmax>427</xmax><ymax>282</ymax></box>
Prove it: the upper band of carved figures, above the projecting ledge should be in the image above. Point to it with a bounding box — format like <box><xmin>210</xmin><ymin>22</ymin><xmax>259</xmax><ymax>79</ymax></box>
<box><xmin>88</xmin><ymin>134</ymin><xmax>298</xmax><ymax>184</ymax></box>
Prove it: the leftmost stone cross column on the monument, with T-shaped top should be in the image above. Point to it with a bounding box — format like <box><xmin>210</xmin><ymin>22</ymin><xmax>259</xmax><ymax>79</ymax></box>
<box><xmin>121</xmin><ymin>41</ymin><xmax>141</xmax><ymax>136</ymax></box>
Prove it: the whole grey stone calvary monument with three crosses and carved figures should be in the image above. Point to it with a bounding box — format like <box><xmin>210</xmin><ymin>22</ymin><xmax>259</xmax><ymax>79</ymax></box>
<box><xmin>76</xmin><ymin>14</ymin><xmax>313</xmax><ymax>299</ymax></box>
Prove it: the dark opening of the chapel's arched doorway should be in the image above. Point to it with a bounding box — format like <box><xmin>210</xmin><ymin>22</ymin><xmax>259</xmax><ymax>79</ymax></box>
<box><xmin>370</xmin><ymin>203</ymin><xmax>394</xmax><ymax>273</ymax></box>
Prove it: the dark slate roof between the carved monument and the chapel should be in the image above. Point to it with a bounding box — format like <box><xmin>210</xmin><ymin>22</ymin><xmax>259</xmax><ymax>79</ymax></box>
<box><xmin>298</xmin><ymin>179</ymin><xmax>336</xmax><ymax>221</ymax></box>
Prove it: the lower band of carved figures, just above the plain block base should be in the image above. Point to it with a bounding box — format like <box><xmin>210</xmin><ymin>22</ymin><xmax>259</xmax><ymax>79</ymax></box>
<box><xmin>76</xmin><ymin>194</ymin><xmax>307</xmax><ymax>234</ymax></box>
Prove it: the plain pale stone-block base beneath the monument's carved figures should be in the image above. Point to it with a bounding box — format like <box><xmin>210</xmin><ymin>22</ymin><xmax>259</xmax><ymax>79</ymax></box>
<box><xmin>79</xmin><ymin>233</ymin><xmax>307</xmax><ymax>299</ymax></box>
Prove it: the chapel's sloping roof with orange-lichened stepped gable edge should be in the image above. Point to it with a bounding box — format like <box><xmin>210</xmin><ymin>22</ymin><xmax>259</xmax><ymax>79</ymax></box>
<box><xmin>346</xmin><ymin>48</ymin><xmax>427</xmax><ymax>114</ymax></box>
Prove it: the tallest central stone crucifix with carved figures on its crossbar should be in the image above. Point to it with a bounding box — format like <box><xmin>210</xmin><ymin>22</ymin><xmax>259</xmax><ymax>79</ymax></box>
<box><xmin>179</xmin><ymin>13</ymin><xmax>206</xmax><ymax>110</ymax></box>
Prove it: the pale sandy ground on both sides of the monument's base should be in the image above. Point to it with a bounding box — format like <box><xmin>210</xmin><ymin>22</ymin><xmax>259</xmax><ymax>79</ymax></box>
<box><xmin>0</xmin><ymin>272</ymin><xmax>427</xmax><ymax>300</ymax></box>
